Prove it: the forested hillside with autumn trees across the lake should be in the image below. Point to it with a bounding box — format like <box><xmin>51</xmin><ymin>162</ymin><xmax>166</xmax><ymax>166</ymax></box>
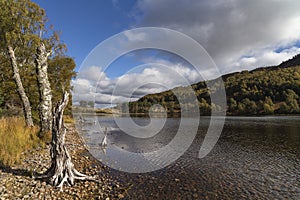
<box><xmin>129</xmin><ymin>55</ymin><xmax>300</xmax><ymax>115</ymax></box>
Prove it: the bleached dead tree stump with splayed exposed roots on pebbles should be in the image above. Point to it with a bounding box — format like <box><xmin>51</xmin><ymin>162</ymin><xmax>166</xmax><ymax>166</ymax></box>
<box><xmin>38</xmin><ymin>92</ymin><xmax>94</xmax><ymax>188</ymax></box>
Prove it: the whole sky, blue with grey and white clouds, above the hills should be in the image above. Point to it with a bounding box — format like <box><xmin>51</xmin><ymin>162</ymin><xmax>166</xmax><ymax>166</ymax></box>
<box><xmin>34</xmin><ymin>0</ymin><xmax>300</xmax><ymax>105</ymax></box>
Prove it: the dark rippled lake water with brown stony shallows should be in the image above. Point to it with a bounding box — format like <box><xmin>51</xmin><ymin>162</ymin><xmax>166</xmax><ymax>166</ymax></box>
<box><xmin>78</xmin><ymin>116</ymin><xmax>300</xmax><ymax>199</ymax></box>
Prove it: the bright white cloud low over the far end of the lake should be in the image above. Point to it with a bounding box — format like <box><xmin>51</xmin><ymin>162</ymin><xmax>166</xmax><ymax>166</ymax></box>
<box><xmin>72</xmin><ymin>60</ymin><xmax>200</xmax><ymax>104</ymax></box>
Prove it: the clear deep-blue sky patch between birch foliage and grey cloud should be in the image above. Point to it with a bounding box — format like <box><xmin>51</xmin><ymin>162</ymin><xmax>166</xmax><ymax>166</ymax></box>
<box><xmin>34</xmin><ymin>0</ymin><xmax>135</xmax><ymax>74</ymax></box>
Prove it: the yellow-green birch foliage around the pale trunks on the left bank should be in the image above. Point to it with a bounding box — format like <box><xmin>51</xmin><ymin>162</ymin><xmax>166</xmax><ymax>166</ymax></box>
<box><xmin>0</xmin><ymin>0</ymin><xmax>76</xmax><ymax>122</ymax></box>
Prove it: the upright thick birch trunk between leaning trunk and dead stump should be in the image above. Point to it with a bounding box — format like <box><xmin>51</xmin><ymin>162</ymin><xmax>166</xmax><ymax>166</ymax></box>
<box><xmin>35</xmin><ymin>44</ymin><xmax>52</xmax><ymax>133</ymax></box>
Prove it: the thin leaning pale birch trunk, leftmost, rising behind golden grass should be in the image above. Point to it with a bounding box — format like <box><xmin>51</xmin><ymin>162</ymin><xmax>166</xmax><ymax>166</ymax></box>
<box><xmin>7</xmin><ymin>46</ymin><xmax>33</xmax><ymax>127</ymax></box>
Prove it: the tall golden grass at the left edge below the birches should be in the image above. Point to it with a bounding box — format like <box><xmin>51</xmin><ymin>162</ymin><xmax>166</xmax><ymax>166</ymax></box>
<box><xmin>0</xmin><ymin>117</ymin><xmax>41</xmax><ymax>166</ymax></box>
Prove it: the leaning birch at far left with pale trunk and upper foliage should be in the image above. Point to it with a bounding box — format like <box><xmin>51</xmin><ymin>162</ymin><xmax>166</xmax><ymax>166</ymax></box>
<box><xmin>0</xmin><ymin>0</ymin><xmax>45</xmax><ymax>126</ymax></box>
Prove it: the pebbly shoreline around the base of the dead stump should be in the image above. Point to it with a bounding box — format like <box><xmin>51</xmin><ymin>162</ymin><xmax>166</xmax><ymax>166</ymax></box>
<box><xmin>0</xmin><ymin>124</ymin><xmax>127</xmax><ymax>200</ymax></box>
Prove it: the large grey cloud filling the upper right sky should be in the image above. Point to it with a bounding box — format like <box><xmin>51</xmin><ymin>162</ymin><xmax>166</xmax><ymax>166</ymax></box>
<box><xmin>136</xmin><ymin>0</ymin><xmax>300</xmax><ymax>73</ymax></box>
